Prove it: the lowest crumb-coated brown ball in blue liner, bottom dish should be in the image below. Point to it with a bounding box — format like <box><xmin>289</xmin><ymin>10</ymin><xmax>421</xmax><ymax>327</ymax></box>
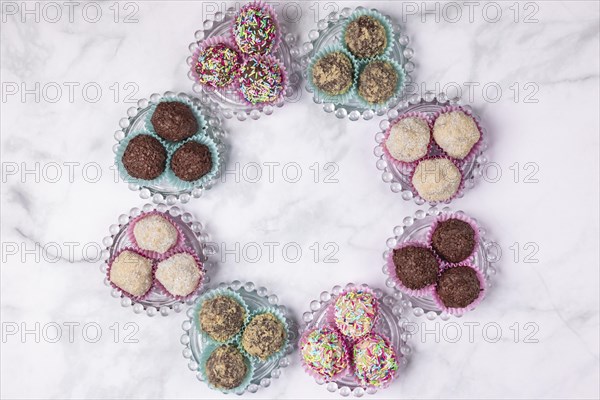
<box><xmin>206</xmin><ymin>345</ymin><xmax>248</xmax><ymax>390</ymax></box>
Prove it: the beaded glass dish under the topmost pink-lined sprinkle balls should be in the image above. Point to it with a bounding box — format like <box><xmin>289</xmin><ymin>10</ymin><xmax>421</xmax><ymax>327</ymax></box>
<box><xmin>186</xmin><ymin>7</ymin><xmax>301</xmax><ymax>121</ymax></box>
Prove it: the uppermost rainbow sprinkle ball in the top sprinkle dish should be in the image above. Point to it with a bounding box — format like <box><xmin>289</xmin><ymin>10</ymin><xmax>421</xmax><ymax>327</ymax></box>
<box><xmin>233</xmin><ymin>3</ymin><xmax>279</xmax><ymax>54</ymax></box>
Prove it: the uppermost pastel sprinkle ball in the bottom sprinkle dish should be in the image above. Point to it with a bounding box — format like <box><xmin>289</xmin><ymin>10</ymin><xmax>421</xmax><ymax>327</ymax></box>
<box><xmin>332</xmin><ymin>289</ymin><xmax>378</xmax><ymax>339</ymax></box>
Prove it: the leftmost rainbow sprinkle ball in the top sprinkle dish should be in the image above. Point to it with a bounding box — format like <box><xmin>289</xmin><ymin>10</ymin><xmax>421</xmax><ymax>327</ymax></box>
<box><xmin>194</xmin><ymin>43</ymin><xmax>242</xmax><ymax>88</ymax></box>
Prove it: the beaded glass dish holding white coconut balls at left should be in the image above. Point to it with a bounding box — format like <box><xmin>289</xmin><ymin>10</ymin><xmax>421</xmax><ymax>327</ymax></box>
<box><xmin>100</xmin><ymin>204</ymin><xmax>214</xmax><ymax>317</ymax></box>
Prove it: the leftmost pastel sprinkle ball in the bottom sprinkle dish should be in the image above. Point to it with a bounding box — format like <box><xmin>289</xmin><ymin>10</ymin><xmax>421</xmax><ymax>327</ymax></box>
<box><xmin>300</xmin><ymin>327</ymin><xmax>348</xmax><ymax>379</ymax></box>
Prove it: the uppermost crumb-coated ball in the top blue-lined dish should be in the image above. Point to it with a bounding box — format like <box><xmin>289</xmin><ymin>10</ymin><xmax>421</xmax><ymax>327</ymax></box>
<box><xmin>344</xmin><ymin>15</ymin><xmax>387</xmax><ymax>58</ymax></box>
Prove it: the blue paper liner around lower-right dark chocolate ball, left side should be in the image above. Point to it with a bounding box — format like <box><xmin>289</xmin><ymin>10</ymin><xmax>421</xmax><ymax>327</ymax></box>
<box><xmin>165</xmin><ymin>134</ymin><xmax>224</xmax><ymax>190</ymax></box>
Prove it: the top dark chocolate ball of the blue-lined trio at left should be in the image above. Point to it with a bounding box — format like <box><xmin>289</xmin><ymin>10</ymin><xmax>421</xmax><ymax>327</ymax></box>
<box><xmin>150</xmin><ymin>101</ymin><xmax>198</xmax><ymax>142</ymax></box>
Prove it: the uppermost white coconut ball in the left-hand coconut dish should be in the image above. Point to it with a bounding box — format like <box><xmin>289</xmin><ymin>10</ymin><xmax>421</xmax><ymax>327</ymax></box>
<box><xmin>133</xmin><ymin>213</ymin><xmax>179</xmax><ymax>254</ymax></box>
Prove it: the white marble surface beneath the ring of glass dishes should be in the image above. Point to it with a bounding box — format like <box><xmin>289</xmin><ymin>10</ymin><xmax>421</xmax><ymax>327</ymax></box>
<box><xmin>0</xmin><ymin>1</ymin><xmax>599</xmax><ymax>399</ymax></box>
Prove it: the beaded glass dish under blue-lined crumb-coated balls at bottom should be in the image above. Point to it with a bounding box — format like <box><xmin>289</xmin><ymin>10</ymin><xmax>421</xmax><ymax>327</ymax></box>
<box><xmin>181</xmin><ymin>281</ymin><xmax>298</xmax><ymax>394</ymax></box>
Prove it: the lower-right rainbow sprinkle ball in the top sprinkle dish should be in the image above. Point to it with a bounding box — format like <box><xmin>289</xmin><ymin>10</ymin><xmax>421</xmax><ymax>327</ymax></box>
<box><xmin>239</xmin><ymin>56</ymin><xmax>285</xmax><ymax>105</ymax></box>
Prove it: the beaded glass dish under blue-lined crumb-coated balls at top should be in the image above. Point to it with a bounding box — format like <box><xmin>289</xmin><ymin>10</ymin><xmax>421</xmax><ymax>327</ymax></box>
<box><xmin>300</xmin><ymin>7</ymin><xmax>415</xmax><ymax>121</ymax></box>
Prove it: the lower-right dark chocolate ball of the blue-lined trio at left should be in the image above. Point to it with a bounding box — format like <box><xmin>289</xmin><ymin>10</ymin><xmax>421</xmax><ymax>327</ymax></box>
<box><xmin>171</xmin><ymin>142</ymin><xmax>213</xmax><ymax>182</ymax></box>
